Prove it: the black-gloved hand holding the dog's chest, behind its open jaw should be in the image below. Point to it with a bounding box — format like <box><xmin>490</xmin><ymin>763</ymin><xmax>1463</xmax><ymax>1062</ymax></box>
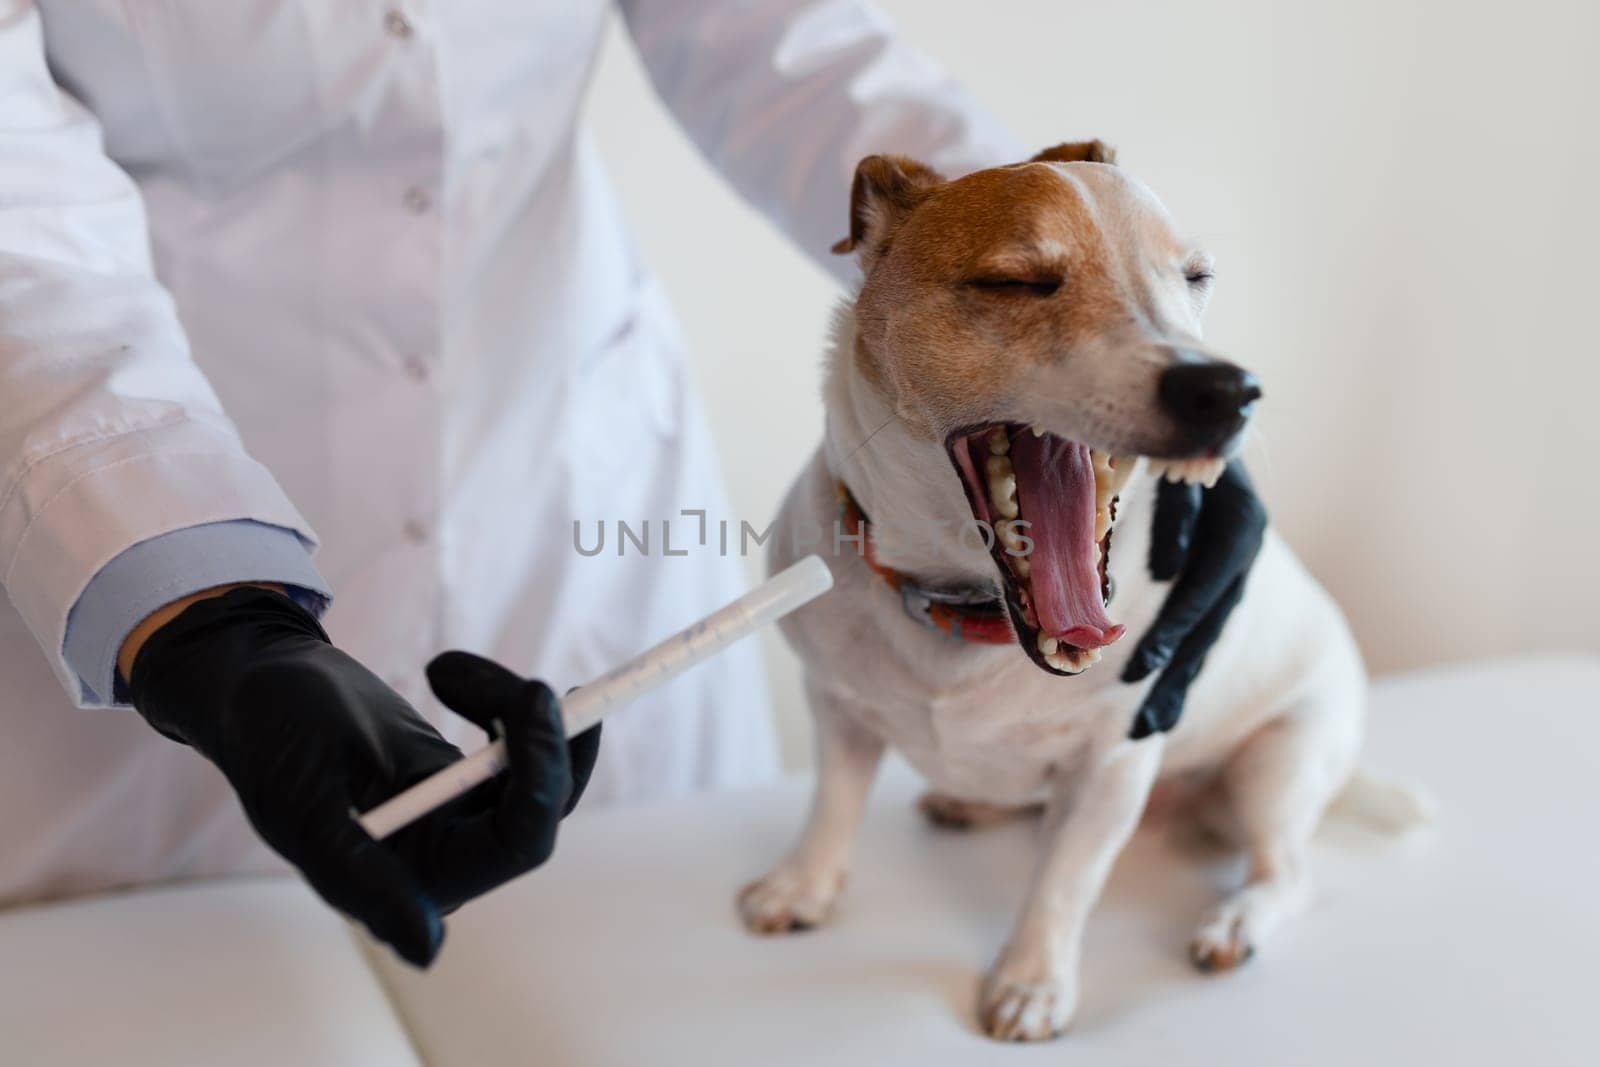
<box><xmin>1122</xmin><ymin>461</ymin><xmax>1267</xmax><ymax>739</ymax></box>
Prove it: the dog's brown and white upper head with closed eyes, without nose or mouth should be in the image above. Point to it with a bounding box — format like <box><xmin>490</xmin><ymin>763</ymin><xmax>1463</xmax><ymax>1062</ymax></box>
<box><xmin>835</xmin><ymin>141</ymin><xmax>1210</xmax><ymax>456</ymax></box>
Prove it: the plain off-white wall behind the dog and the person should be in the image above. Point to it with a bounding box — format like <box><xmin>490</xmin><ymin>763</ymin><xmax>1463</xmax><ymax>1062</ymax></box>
<box><xmin>590</xmin><ymin>0</ymin><xmax>1600</xmax><ymax>761</ymax></box>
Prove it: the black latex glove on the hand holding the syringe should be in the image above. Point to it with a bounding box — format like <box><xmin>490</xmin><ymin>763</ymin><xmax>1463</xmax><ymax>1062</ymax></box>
<box><xmin>128</xmin><ymin>587</ymin><xmax>600</xmax><ymax>966</ymax></box>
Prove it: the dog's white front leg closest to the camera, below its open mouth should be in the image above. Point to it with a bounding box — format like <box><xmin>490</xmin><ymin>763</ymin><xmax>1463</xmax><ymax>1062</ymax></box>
<box><xmin>979</xmin><ymin>736</ymin><xmax>1163</xmax><ymax>1041</ymax></box>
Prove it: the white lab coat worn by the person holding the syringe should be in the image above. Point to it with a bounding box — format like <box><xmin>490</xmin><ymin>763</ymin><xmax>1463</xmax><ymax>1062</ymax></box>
<box><xmin>0</xmin><ymin>0</ymin><xmax>1014</xmax><ymax>902</ymax></box>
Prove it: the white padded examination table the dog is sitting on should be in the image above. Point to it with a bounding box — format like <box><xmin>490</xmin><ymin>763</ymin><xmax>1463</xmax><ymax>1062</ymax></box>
<box><xmin>0</xmin><ymin>657</ymin><xmax>1600</xmax><ymax>1067</ymax></box>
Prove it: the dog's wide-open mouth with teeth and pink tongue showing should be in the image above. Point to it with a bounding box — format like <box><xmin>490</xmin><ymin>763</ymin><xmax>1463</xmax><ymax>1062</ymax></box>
<box><xmin>946</xmin><ymin>422</ymin><xmax>1221</xmax><ymax>675</ymax></box>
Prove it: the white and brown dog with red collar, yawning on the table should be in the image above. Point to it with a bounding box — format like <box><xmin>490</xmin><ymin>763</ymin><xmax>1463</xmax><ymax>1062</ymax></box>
<box><xmin>739</xmin><ymin>142</ymin><xmax>1427</xmax><ymax>1040</ymax></box>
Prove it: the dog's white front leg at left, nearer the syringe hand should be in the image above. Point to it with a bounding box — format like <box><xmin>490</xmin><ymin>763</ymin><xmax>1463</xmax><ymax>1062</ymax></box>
<box><xmin>739</xmin><ymin>693</ymin><xmax>883</xmax><ymax>934</ymax></box>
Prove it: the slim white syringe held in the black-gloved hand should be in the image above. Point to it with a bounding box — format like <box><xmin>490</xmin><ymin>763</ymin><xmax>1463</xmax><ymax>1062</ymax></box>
<box><xmin>358</xmin><ymin>555</ymin><xmax>834</xmax><ymax>840</ymax></box>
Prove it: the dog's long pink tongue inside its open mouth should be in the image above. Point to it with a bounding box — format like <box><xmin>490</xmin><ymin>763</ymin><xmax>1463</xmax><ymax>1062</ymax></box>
<box><xmin>1011</xmin><ymin>430</ymin><xmax>1125</xmax><ymax>648</ymax></box>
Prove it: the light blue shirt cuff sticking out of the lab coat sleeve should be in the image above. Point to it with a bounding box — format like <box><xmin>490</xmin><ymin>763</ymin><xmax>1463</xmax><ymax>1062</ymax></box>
<box><xmin>62</xmin><ymin>518</ymin><xmax>331</xmax><ymax>705</ymax></box>
